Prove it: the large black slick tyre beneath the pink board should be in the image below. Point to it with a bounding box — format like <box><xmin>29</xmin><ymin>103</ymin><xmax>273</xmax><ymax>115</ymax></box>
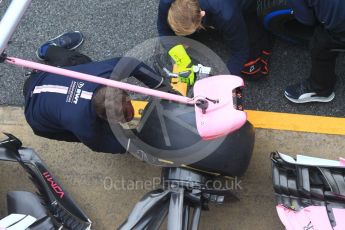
<box><xmin>127</xmin><ymin>100</ymin><xmax>255</xmax><ymax>177</ymax></box>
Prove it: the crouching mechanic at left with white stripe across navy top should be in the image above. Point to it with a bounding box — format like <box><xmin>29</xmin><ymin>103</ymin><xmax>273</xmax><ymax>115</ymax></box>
<box><xmin>23</xmin><ymin>32</ymin><xmax>163</xmax><ymax>153</ymax></box>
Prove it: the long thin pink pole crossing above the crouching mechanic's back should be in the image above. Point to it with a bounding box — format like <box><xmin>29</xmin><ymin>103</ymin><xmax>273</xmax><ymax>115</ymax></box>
<box><xmin>6</xmin><ymin>57</ymin><xmax>195</xmax><ymax>105</ymax></box>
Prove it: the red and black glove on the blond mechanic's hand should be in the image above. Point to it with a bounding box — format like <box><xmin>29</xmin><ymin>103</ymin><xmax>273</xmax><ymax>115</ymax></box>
<box><xmin>241</xmin><ymin>51</ymin><xmax>270</xmax><ymax>80</ymax></box>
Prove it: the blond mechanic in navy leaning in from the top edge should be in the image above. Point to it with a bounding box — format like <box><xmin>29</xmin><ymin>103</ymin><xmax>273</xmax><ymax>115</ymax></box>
<box><xmin>157</xmin><ymin>0</ymin><xmax>273</xmax><ymax>79</ymax></box>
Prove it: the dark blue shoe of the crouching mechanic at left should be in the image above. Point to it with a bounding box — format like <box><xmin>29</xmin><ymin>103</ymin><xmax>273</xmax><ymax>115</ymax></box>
<box><xmin>36</xmin><ymin>31</ymin><xmax>84</xmax><ymax>60</ymax></box>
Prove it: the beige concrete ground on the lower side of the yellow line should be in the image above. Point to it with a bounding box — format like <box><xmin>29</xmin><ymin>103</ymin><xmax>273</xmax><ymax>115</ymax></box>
<box><xmin>0</xmin><ymin>107</ymin><xmax>345</xmax><ymax>230</ymax></box>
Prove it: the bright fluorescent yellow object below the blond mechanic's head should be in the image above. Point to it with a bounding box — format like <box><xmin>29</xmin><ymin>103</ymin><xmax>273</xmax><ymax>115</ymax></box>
<box><xmin>168</xmin><ymin>44</ymin><xmax>195</xmax><ymax>85</ymax></box>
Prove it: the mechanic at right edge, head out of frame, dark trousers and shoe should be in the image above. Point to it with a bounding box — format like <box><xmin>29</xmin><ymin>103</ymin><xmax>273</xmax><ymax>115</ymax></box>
<box><xmin>285</xmin><ymin>0</ymin><xmax>345</xmax><ymax>103</ymax></box>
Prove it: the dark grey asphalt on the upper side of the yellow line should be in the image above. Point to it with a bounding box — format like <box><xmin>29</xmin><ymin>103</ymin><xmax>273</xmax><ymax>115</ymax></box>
<box><xmin>0</xmin><ymin>0</ymin><xmax>345</xmax><ymax>117</ymax></box>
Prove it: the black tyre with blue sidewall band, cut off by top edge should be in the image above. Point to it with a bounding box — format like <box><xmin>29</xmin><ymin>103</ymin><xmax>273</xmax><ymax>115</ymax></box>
<box><xmin>257</xmin><ymin>0</ymin><xmax>314</xmax><ymax>46</ymax></box>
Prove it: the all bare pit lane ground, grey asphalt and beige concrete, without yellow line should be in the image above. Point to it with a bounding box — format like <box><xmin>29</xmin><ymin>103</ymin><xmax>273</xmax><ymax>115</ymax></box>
<box><xmin>0</xmin><ymin>0</ymin><xmax>345</xmax><ymax>230</ymax></box>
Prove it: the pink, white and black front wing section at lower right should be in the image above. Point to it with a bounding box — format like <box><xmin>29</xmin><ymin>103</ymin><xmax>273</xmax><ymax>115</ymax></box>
<box><xmin>271</xmin><ymin>153</ymin><xmax>345</xmax><ymax>230</ymax></box>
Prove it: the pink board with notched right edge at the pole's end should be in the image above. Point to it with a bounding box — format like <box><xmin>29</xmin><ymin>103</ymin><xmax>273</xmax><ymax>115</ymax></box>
<box><xmin>194</xmin><ymin>75</ymin><xmax>247</xmax><ymax>140</ymax></box>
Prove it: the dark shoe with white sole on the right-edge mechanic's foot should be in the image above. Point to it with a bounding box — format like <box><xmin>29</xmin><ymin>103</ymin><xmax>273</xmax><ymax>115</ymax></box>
<box><xmin>284</xmin><ymin>80</ymin><xmax>335</xmax><ymax>103</ymax></box>
